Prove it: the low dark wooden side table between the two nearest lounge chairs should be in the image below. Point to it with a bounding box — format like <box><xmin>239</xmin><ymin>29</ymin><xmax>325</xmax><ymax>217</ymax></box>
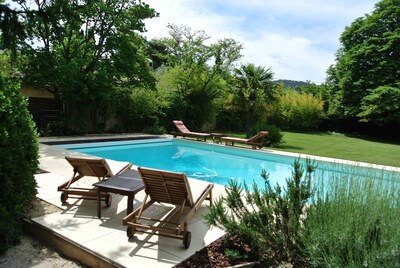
<box><xmin>93</xmin><ymin>169</ymin><xmax>144</xmax><ymax>218</ymax></box>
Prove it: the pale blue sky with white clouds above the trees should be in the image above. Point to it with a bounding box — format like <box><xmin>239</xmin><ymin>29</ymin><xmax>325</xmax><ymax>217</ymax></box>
<box><xmin>144</xmin><ymin>0</ymin><xmax>378</xmax><ymax>84</ymax></box>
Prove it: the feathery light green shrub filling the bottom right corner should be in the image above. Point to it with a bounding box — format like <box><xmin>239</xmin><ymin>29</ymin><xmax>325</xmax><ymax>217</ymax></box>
<box><xmin>302</xmin><ymin>166</ymin><xmax>400</xmax><ymax>267</ymax></box>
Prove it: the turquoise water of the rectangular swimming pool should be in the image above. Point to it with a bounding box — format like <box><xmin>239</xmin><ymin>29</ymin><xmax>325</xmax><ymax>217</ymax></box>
<box><xmin>58</xmin><ymin>138</ymin><xmax>398</xmax><ymax>187</ymax></box>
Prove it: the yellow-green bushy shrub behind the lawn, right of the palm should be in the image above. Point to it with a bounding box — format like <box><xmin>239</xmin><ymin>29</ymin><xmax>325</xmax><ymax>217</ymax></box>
<box><xmin>277</xmin><ymin>90</ymin><xmax>324</xmax><ymax>131</ymax></box>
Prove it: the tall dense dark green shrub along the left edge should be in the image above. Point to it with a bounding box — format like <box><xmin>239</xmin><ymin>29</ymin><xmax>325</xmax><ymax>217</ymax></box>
<box><xmin>0</xmin><ymin>58</ymin><xmax>38</xmax><ymax>253</ymax></box>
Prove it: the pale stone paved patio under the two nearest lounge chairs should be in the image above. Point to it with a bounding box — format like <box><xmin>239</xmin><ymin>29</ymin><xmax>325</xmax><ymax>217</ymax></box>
<box><xmin>32</xmin><ymin>136</ymin><xmax>224</xmax><ymax>267</ymax></box>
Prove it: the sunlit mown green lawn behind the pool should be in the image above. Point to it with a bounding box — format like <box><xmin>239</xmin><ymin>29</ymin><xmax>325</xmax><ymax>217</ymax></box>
<box><xmin>220</xmin><ymin>132</ymin><xmax>400</xmax><ymax>167</ymax></box>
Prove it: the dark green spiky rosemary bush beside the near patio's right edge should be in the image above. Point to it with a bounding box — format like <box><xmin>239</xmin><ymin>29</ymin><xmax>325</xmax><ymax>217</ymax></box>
<box><xmin>205</xmin><ymin>160</ymin><xmax>315</xmax><ymax>266</ymax></box>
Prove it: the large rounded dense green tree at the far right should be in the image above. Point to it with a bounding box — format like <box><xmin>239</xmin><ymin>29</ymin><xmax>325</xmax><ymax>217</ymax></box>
<box><xmin>328</xmin><ymin>0</ymin><xmax>400</xmax><ymax>127</ymax></box>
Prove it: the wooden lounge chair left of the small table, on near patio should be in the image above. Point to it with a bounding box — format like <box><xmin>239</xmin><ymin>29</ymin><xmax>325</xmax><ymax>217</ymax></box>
<box><xmin>58</xmin><ymin>156</ymin><xmax>132</xmax><ymax>207</ymax></box>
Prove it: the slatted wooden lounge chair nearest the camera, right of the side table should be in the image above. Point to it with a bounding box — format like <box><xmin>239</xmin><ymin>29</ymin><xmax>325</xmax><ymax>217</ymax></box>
<box><xmin>123</xmin><ymin>167</ymin><xmax>214</xmax><ymax>249</ymax></box>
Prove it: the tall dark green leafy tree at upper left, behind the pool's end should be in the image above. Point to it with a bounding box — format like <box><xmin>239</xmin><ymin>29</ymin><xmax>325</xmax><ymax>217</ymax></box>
<box><xmin>1</xmin><ymin>0</ymin><xmax>156</xmax><ymax>132</ymax></box>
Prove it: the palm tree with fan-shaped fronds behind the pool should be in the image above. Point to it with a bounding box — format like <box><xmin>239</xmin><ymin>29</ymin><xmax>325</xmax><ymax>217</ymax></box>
<box><xmin>234</xmin><ymin>63</ymin><xmax>273</xmax><ymax>137</ymax></box>
